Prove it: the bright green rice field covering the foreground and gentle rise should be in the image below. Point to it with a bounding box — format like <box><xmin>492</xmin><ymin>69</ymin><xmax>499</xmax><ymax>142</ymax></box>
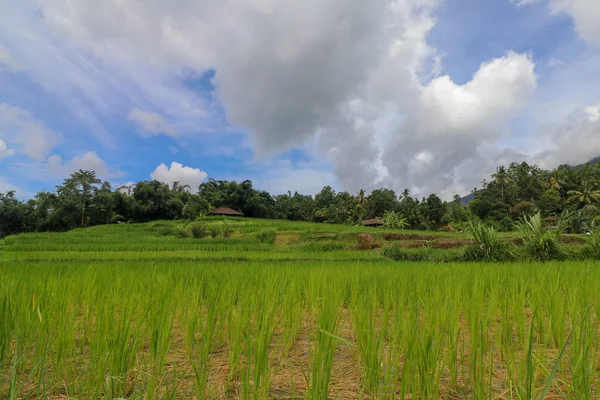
<box><xmin>0</xmin><ymin>220</ymin><xmax>600</xmax><ymax>400</ymax></box>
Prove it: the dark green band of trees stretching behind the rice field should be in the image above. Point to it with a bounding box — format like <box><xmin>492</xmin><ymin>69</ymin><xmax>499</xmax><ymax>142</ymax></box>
<box><xmin>0</xmin><ymin>163</ymin><xmax>600</xmax><ymax>237</ymax></box>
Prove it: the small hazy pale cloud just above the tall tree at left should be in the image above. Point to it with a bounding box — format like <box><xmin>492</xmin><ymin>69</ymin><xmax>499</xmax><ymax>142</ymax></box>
<box><xmin>46</xmin><ymin>151</ymin><xmax>124</xmax><ymax>179</ymax></box>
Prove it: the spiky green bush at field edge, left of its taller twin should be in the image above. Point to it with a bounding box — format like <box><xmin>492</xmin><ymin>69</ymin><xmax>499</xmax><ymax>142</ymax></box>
<box><xmin>462</xmin><ymin>222</ymin><xmax>515</xmax><ymax>262</ymax></box>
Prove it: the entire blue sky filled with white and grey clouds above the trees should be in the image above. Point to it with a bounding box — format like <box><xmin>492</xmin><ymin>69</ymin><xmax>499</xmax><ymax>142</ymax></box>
<box><xmin>0</xmin><ymin>0</ymin><xmax>600</xmax><ymax>198</ymax></box>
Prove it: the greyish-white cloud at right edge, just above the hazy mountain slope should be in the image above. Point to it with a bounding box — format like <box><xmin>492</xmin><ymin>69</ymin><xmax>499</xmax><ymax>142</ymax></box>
<box><xmin>536</xmin><ymin>104</ymin><xmax>600</xmax><ymax>168</ymax></box>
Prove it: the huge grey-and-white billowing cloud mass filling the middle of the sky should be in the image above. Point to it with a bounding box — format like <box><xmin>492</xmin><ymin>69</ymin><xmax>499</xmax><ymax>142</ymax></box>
<box><xmin>0</xmin><ymin>0</ymin><xmax>536</xmax><ymax>197</ymax></box>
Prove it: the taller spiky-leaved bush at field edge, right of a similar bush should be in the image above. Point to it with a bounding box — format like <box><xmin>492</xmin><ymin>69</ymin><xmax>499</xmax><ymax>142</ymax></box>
<box><xmin>516</xmin><ymin>213</ymin><xmax>567</xmax><ymax>261</ymax></box>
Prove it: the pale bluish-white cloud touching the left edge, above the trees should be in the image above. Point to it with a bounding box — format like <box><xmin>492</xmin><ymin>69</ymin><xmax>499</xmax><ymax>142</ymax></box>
<box><xmin>0</xmin><ymin>103</ymin><xmax>62</xmax><ymax>161</ymax></box>
